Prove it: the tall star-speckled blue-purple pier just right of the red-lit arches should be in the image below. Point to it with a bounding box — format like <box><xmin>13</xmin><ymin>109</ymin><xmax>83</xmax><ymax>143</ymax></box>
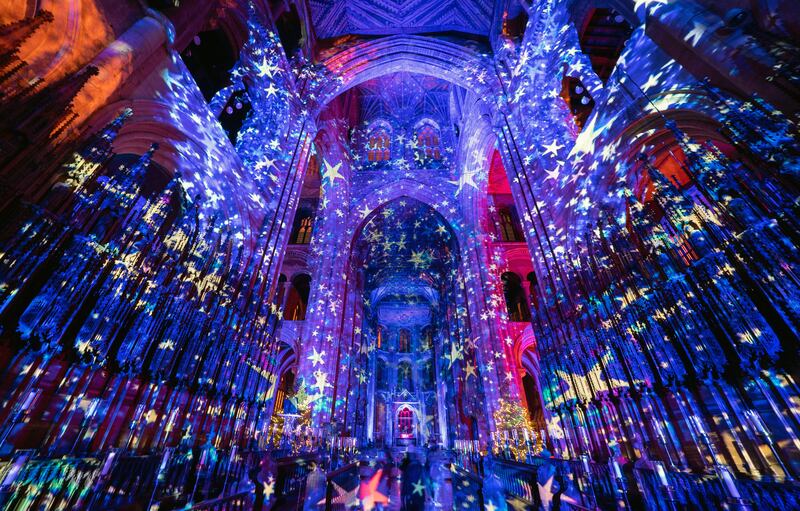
<box><xmin>494</xmin><ymin>3</ymin><xmax>591</xmax><ymax>450</ymax></box>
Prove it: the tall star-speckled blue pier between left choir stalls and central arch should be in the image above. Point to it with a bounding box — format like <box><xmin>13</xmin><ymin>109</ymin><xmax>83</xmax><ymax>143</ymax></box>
<box><xmin>216</xmin><ymin>11</ymin><xmax>316</xmax><ymax>444</ymax></box>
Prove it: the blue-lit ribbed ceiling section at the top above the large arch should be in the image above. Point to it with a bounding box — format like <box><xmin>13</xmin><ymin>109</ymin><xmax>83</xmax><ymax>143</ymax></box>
<box><xmin>309</xmin><ymin>0</ymin><xmax>495</xmax><ymax>39</ymax></box>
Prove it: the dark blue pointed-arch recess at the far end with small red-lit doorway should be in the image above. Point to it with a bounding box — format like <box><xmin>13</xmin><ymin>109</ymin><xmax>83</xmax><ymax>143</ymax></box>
<box><xmin>351</xmin><ymin>197</ymin><xmax>470</xmax><ymax>446</ymax></box>
